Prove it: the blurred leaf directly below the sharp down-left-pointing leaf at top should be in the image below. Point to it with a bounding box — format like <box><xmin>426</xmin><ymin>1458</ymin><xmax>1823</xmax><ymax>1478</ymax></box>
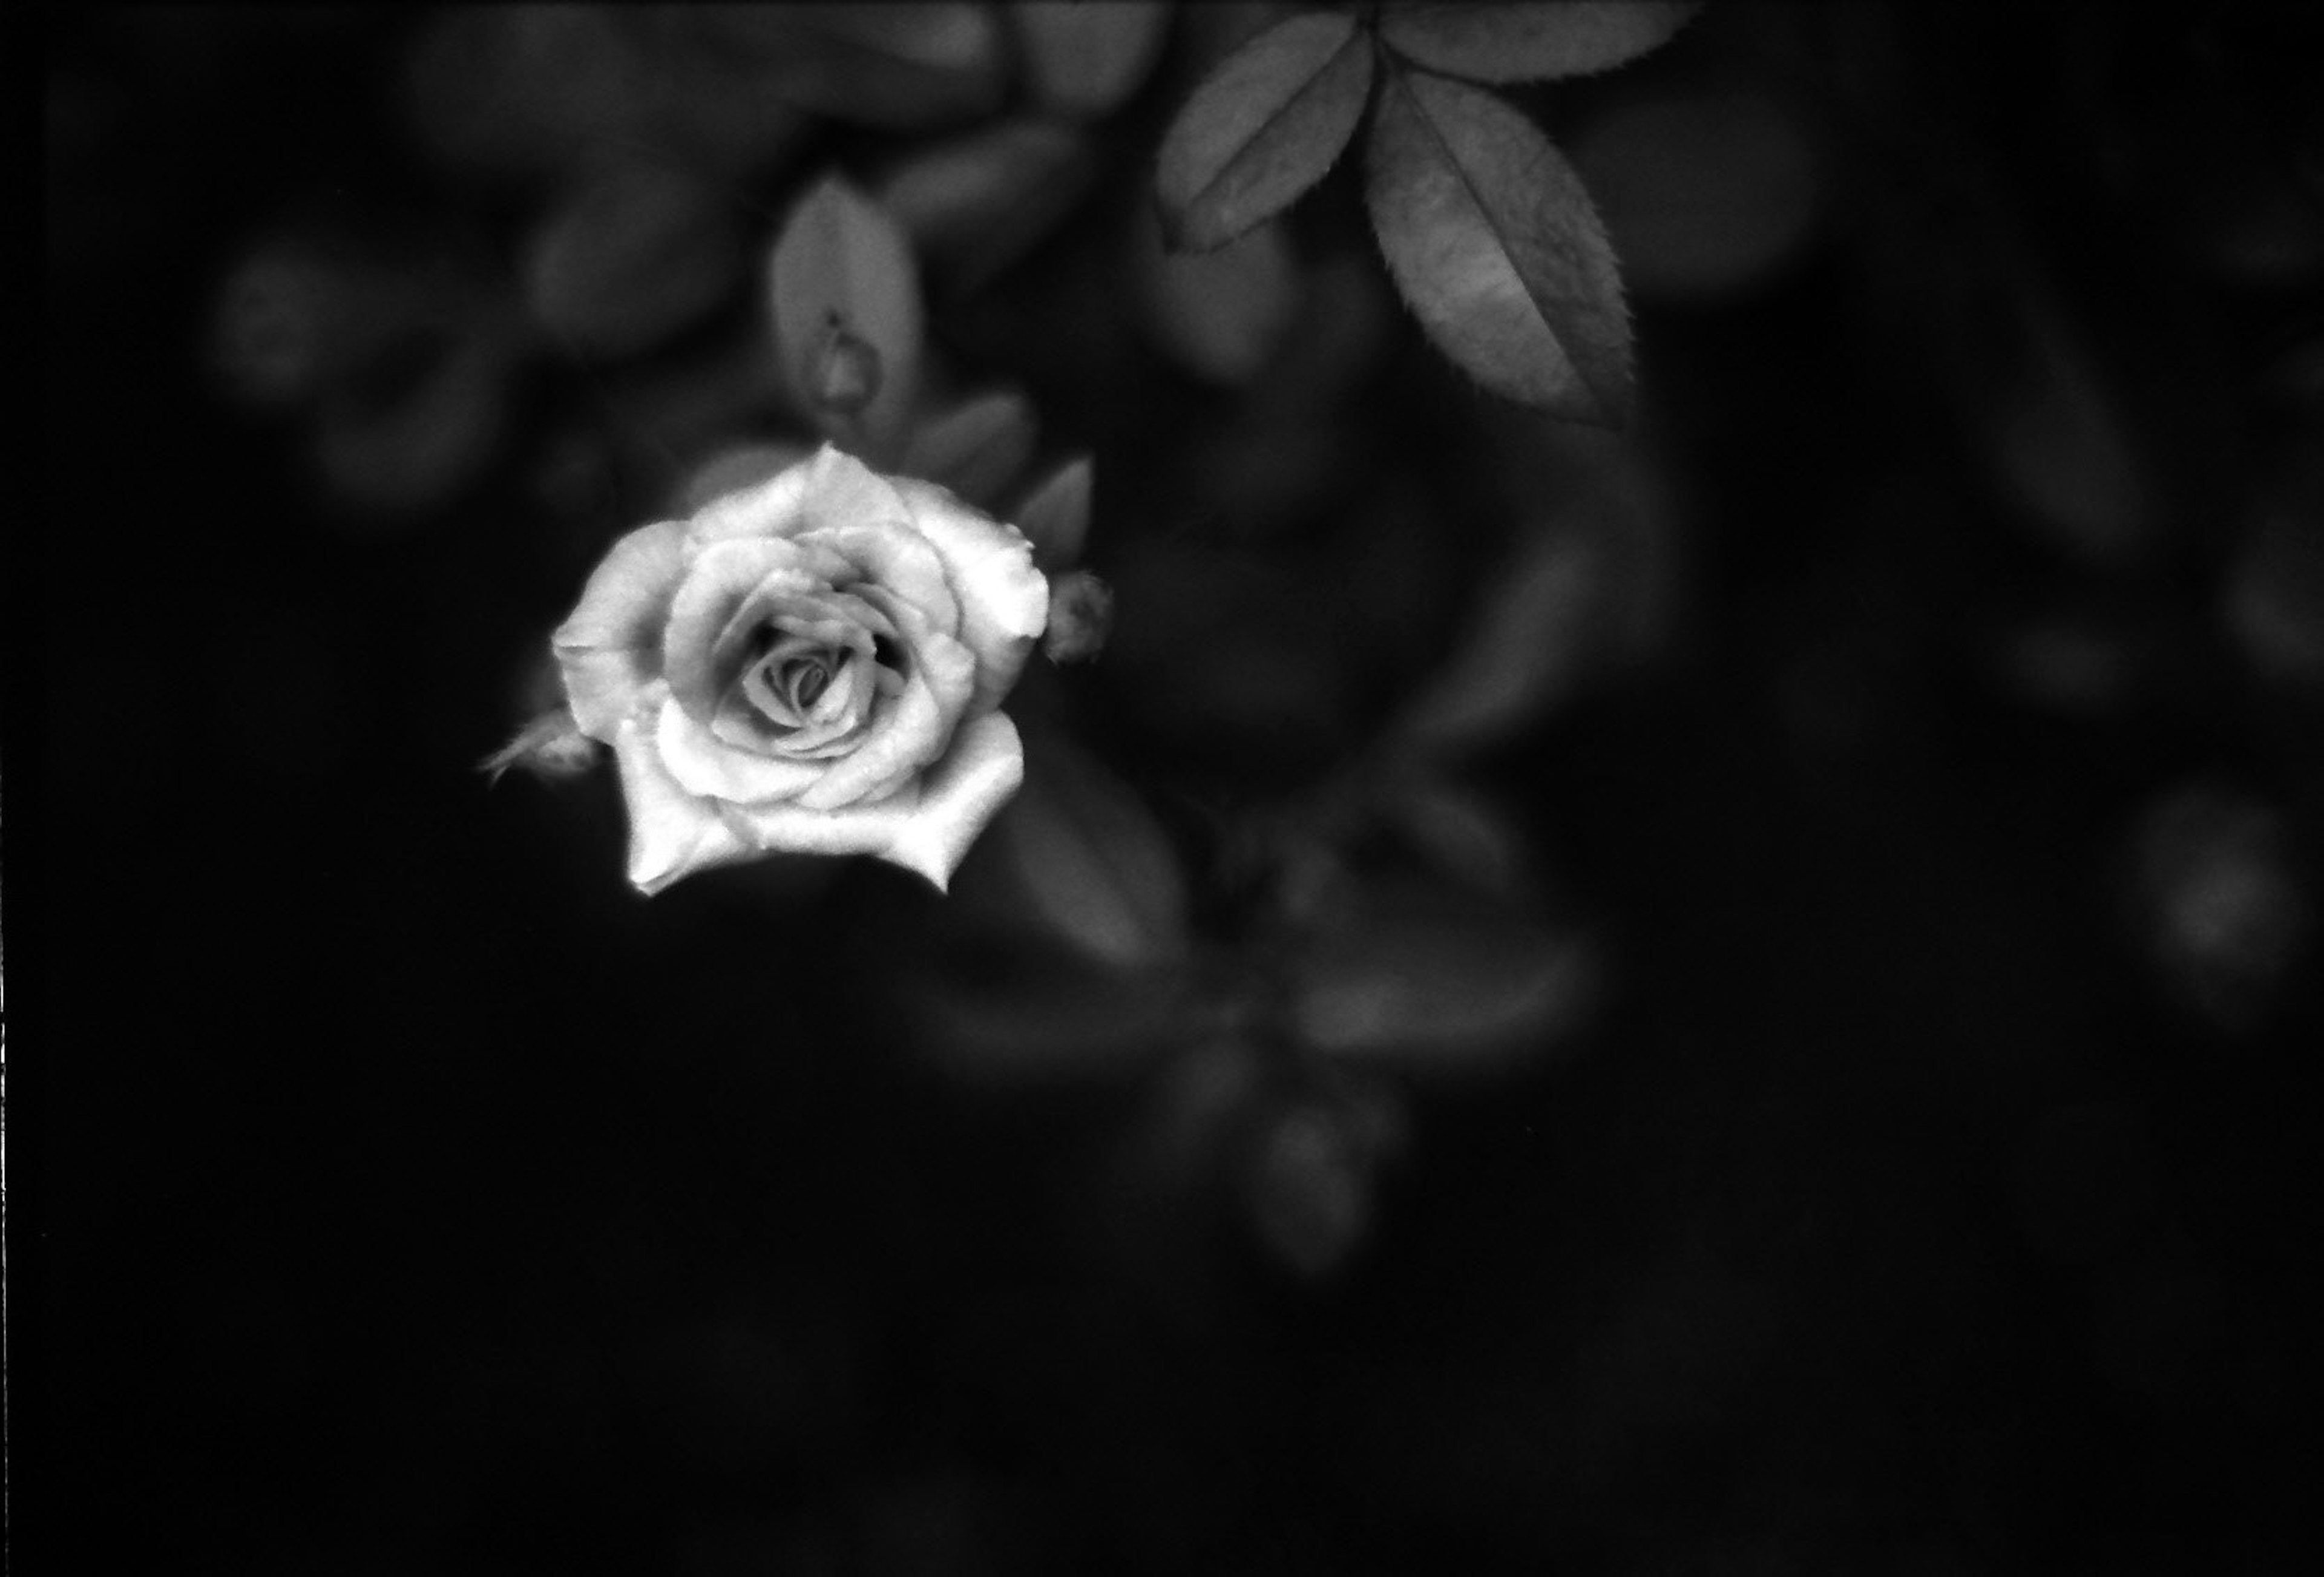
<box><xmin>1132</xmin><ymin>214</ymin><xmax>1301</xmax><ymax>388</ymax></box>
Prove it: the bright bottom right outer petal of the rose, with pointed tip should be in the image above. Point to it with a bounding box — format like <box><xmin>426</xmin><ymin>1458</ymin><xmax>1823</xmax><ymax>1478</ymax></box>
<box><xmin>732</xmin><ymin>713</ymin><xmax>1025</xmax><ymax>892</ymax></box>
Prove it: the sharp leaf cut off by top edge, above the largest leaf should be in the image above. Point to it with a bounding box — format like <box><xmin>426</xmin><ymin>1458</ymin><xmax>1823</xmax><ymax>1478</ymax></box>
<box><xmin>1380</xmin><ymin>0</ymin><xmax>1696</xmax><ymax>81</ymax></box>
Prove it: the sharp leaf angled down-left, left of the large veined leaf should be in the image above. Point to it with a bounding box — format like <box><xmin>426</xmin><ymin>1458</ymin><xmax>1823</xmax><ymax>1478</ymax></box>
<box><xmin>1155</xmin><ymin>14</ymin><xmax>1371</xmax><ymax>251</ymax></box>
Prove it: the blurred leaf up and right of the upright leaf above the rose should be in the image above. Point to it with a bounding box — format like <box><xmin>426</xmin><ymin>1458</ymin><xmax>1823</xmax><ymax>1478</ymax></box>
<box><xmin>874</xmin><ymin>121</ymin><xmax>1097</xmax><ymax>290</ymax></box>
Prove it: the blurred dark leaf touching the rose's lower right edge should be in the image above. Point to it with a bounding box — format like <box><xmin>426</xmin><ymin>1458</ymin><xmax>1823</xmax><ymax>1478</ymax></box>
<box><xmin>985</xmin><ymin>736</ymin><xmax>1187</xmax><ymax>971</ymax></box>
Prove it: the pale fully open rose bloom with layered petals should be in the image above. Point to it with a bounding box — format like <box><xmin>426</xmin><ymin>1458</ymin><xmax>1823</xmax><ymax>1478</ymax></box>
<box><xmin>551</xmin><ymin>446</ymin><xmax>1048</xmax><ymax>892</ymax></box>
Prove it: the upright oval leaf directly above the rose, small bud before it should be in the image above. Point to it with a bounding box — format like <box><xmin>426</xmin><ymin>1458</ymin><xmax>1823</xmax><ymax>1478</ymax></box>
<box><xmin>769</xmin><ymin>174</ymin><xmax>922</xmax><ymax>457</ymax></box>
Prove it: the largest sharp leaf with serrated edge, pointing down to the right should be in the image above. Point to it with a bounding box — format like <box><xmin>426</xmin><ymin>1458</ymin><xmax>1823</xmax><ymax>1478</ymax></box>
<box><xmin>1367</xmin><ymin>72</ymin><xmax>1632</xmax><ymax>427</ymax></box>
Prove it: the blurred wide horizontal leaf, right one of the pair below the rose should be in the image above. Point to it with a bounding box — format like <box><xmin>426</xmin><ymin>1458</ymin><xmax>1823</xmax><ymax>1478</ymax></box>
<box><xmin>1290</xmin><ymin>882</ymin><xmax>1597</xmax><ymax>1078</ymax></box>
